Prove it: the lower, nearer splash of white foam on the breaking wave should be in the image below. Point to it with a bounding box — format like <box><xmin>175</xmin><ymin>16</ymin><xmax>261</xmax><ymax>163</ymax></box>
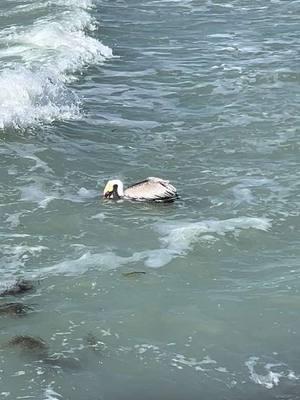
<box><xmin>0</xmin><ymin>67</ymin><xmax>80</xmax><ymax>129</ymax></box>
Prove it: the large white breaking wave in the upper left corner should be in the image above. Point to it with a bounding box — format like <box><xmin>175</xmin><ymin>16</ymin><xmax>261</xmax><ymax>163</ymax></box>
<box><xmin>0</xmin><ymin>0</ymin><xmax>112</xmax><ymax>129</ymax></box>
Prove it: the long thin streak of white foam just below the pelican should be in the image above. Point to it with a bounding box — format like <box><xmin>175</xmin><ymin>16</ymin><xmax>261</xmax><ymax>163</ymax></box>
<box><xmin>35</xmin><ymin>215</ymin><xmax>271</xmax><ymax>276</ymax></box>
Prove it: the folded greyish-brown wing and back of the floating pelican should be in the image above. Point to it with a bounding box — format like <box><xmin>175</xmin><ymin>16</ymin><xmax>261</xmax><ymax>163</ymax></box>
<box><xmin>124</xmin><ymin>177</ymin><xmax>177</xmax><ymax>201</ymax></box>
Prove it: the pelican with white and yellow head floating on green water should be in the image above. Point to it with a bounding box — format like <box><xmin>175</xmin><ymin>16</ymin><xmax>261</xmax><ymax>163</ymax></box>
<box><xmin>103</xmin><ymin>176</ymin><xmax>178</xmax><ymax>202</ymax></box>
